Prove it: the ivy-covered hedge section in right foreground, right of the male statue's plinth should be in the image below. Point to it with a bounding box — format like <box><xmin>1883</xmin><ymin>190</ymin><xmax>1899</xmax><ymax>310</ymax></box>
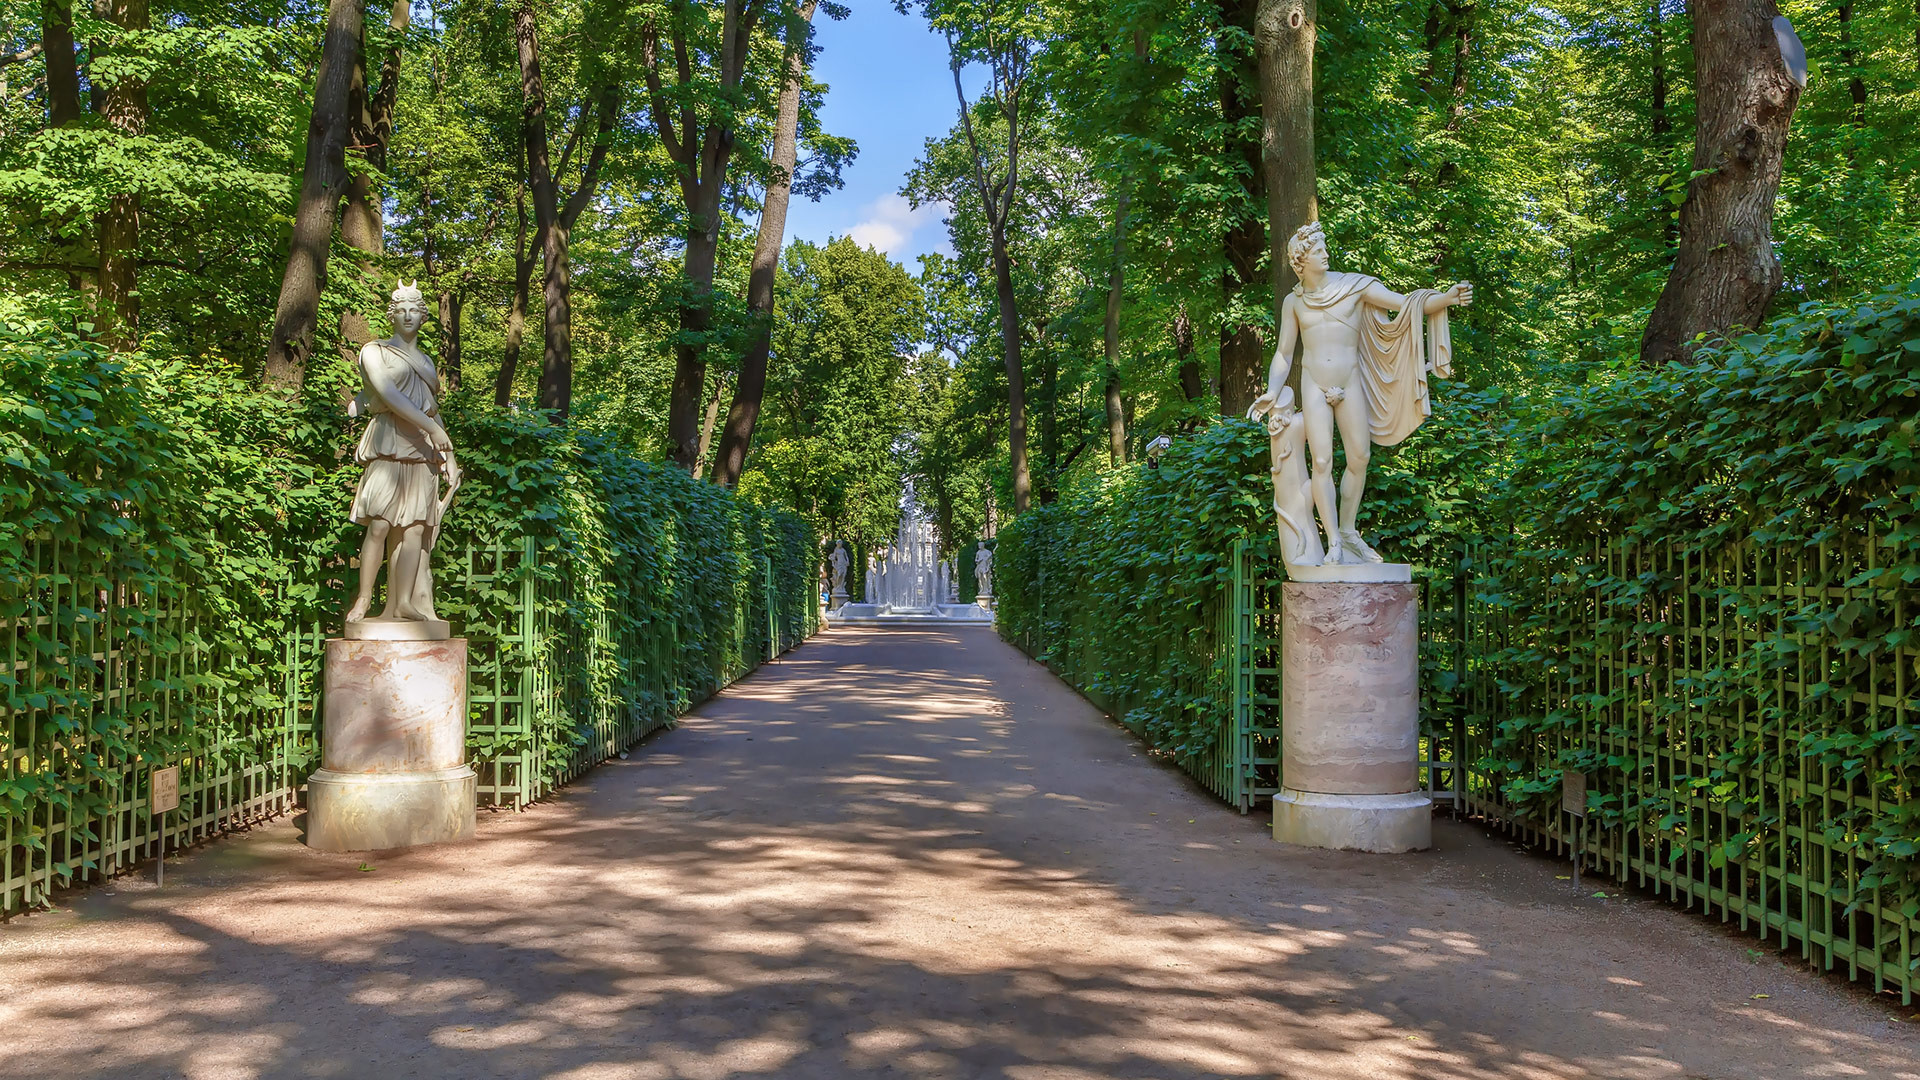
<box><xmin>1469</xmin><ymin>284</ymin><xmax>1920</xmax><ymax>992</ymax></box>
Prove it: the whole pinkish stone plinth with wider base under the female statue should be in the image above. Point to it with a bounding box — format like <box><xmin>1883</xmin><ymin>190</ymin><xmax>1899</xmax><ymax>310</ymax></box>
<box><xmin>307</xmin><ymin>638</ymin><xmax>474</xmax><ymax>851</ymax></box>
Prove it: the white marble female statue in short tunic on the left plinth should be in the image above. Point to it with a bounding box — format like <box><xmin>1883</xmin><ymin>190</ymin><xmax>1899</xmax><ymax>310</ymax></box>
<box><xmin>346</xmin><ymin>282</ymin><xmax>461</xmax><ymax>638</ymax></box>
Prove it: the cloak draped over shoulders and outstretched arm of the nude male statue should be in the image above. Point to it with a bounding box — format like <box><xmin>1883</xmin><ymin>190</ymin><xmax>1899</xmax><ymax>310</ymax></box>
<box><xmin>1294</xmin><ymin>273</ymin><xmax>1453</xmax><ymax>446</ymax></box>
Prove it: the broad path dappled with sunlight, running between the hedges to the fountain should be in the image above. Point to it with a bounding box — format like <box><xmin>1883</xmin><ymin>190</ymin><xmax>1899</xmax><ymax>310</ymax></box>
<box><xmin>0</xmin><ymin>628</ymin><xmax>1920</xmax><ymax>1080</ymax></box>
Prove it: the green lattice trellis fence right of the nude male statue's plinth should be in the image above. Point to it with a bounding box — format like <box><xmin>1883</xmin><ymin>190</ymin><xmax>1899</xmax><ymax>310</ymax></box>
<box><xmin>1461</xmin><ymin>532</ymin><xmax>1920</xmax><ymax>1001</ymax></box>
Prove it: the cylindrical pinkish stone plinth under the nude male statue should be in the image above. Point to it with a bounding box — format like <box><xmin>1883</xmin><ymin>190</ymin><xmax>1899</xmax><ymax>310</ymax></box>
<box><xmin>1273</xmin><ymin>575</ymin><xmax>1432</xmax><ymax>851</ymax></box>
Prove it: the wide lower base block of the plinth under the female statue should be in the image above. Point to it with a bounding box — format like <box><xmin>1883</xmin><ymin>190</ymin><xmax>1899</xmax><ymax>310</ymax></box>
<box><xmin>307</xmin><ymin>765</ymin><xmax>476</xmax><ymax>851</ymax></box>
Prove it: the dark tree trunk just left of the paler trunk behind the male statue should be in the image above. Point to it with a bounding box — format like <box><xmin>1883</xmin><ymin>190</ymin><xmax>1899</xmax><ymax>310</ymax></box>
<box><xmin>1217</xmin><ymin>0</ymin><xmax>1267</xmax><ymax>417</ymax></box>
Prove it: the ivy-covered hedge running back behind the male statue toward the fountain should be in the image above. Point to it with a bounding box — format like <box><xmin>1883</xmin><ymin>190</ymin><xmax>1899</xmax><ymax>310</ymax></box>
<box><xmin>993</xmin><ymin>399</ymin><xmax>1498</xmax><ymax>759</ymax></box>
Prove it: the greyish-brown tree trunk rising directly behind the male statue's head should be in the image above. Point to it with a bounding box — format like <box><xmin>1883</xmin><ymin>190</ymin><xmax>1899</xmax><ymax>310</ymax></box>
<box><xmin>1242</xmin><ymin>0</ymin><xmax>1319</xmax><ymax>307</ymax></box>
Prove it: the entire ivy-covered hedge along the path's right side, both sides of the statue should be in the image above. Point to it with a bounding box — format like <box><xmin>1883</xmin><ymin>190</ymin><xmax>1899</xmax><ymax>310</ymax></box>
<box><xmin>995</xmin><ymin>284</ymin><xmax>1920</xmax><ymax>994</ymax></box>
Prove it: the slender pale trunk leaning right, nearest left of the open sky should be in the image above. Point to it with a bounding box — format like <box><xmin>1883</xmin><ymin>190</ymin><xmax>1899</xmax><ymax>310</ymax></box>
<box><xmin>712</xmin><ymin>0</ymin><xmax>814</xmax><ymax>488</ymax></box>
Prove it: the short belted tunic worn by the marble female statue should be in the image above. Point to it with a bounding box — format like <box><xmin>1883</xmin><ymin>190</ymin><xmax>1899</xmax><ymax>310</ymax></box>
<box><xmin>348</xmin><ymin>342</ymin><xmax>440</xmax><ymax>528</ymax></box>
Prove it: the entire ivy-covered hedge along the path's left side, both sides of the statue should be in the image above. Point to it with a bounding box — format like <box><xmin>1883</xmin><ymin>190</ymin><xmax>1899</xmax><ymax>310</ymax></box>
<box><xmin>0</xmin><ymin>327</ymin><xmax>818</xmax><ymax>911</ymax></box>
